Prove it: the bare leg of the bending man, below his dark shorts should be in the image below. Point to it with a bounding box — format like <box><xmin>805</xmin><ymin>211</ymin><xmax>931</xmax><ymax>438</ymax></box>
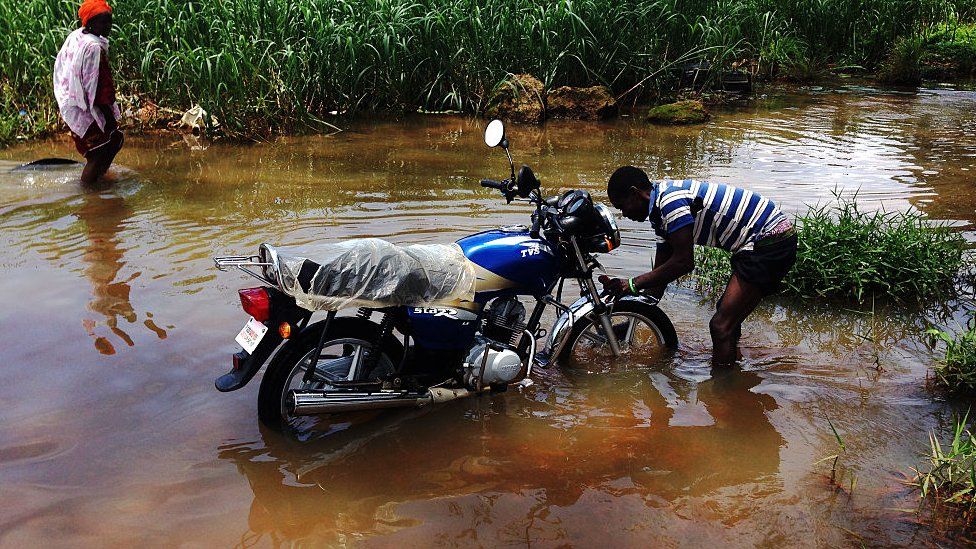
<box><xmin>708</xmin><ymin>274</ymin><xmax>763</xmax><ymax>367</ymax></box>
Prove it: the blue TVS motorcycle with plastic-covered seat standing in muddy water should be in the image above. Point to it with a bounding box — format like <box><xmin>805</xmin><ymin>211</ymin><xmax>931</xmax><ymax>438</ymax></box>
<box><xmin>214</xmin><ymin>120</ymin><xmax>677</xmax><ymax>430</ymax></box>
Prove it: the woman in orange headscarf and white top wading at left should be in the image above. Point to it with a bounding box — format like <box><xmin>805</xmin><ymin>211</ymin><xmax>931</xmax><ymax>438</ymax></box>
<box><xmin>54</xmin><ymin>0</ymin><xmax>123</xmax><ymax>185</ymax></box>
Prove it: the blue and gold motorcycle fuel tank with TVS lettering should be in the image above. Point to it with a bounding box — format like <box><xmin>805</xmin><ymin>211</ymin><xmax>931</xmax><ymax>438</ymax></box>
<box><xmin>457</xmin><ymin>228</ymin><xmax>559</xmax><ymax>302</ymax></box>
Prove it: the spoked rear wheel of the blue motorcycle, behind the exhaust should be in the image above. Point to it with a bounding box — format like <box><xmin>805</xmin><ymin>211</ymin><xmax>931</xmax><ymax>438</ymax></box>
<box><xmin>258</xmin><ymin>317</ymin><xmax>403</xmax><ymax>431</ymax></box>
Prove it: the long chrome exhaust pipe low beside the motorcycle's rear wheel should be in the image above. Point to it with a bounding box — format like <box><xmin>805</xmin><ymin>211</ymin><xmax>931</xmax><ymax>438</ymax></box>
<box><xmin>286</xmin><ymin>387</ymin><xmax>475</xmax><ymax>416</ymax></box>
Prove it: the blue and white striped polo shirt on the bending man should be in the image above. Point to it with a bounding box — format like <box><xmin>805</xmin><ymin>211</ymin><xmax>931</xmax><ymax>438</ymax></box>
<box><xmin>649</xmin><ymin>179</ymin><xmax>786</xmax><ymax>253</ymax></box>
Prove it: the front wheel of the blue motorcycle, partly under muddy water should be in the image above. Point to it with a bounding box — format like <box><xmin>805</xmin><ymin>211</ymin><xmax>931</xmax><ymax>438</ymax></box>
<box><xmin>558</xmin><ymin>299</ymin><xmax>678</xmax><ymax>364</ymax></box>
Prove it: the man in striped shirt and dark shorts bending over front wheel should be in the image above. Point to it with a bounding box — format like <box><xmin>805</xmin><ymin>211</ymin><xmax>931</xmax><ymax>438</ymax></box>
<box><xmin>603</xmin><ymin>166</ymin><xmax>797</xmax><ymax>366</ymax></box>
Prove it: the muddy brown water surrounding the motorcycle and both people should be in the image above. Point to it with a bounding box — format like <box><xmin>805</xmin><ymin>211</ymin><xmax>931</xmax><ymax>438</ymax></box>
<box><xmin>0</xmin><ymin>86</ymin><xmax>976</xmax><ymax>547</ymax></box>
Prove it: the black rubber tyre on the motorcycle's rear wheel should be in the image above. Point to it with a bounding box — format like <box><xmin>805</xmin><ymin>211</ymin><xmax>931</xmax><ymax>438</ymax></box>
<box><xmin>258</xmin><ymin>317</ymin><xmax>403</xmax><ymax>431</ymax></box>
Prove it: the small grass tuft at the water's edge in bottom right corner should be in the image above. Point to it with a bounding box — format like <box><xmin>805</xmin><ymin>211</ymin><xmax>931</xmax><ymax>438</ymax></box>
<box><xmin>915</xmin><ymin>414</ymin><xmax>976</xmax><ymax>530</ymax></box>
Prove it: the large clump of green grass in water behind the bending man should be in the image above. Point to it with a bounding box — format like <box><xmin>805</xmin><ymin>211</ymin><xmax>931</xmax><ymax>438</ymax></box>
<box><xmin>695</xmin><ymin>197</ymin><xmax>965</xmax><ymax>303</ymax></box>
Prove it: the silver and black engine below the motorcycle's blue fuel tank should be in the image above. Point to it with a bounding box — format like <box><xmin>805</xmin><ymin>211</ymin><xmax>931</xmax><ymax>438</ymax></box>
<box><xmin>462</xmin><ymin>297</ymin><xmax>525</xmax><ymax>387</ymax></box>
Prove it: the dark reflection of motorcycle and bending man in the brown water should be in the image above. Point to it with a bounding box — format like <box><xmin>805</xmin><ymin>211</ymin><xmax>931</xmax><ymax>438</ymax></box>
<box><xmin>219</xmin><ymin>370</ymin><xmax>784</xmax><ymax>545</ymax></box>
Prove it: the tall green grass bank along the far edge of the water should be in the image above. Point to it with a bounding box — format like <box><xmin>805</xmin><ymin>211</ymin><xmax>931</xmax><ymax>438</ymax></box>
<box><xmin>0</xmin><ymin>0</ymin><xmax>974</xmax><ymax>141</ymax></box>
